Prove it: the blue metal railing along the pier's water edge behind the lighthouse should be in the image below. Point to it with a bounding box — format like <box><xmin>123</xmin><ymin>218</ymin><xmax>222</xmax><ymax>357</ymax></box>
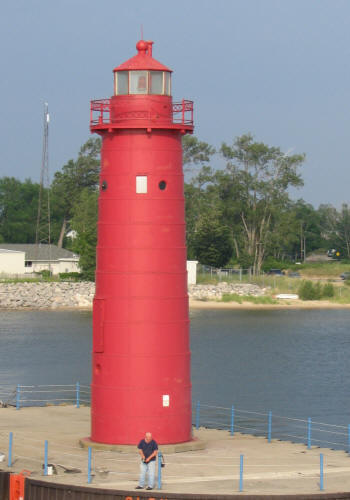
<box><xmin>4</xmin><ymin>382</ymin><xmax>350</xmax><ymax>454</ymax></box>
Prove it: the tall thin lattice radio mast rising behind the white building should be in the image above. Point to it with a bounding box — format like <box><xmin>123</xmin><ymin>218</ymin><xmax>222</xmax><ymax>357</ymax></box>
<box><xmin>35</xmin><ymin>102</ymin><xmax>51</xmax><ymax>248</ymax></box>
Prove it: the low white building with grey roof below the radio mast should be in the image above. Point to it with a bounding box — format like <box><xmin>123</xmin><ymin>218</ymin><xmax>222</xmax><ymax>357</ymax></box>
<box><xmin>0</xmin><ymin>243</ymin><xmax>80</xmax><ymax>275</ymax></box>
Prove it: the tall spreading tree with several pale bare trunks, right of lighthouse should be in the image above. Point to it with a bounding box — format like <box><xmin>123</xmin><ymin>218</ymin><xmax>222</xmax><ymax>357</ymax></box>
<box><xmin>219</xmin><ymin>134</ymin><xmax>305</xmax><ymax>273</ymax></box>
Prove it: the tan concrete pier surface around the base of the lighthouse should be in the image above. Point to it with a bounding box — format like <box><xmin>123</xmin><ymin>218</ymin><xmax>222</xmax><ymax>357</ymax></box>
<box><xmin>0</xmin><ymin>406</ymin><xmax>350</xmax><ymax>495</ymax></box>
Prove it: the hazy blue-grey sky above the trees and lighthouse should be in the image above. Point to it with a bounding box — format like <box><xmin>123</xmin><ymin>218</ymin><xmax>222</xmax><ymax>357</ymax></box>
<box><xmin>0</xmin><ymin>0</ymin><xmax>350</xmax><ymax>206</ymax></box>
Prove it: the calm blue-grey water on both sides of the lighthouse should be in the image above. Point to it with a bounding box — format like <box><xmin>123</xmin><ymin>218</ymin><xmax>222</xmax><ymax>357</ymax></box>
<box><xmin>0</xmin><ymin>310</ymin><xmax>350</xmax><ymax>425</ymax></box>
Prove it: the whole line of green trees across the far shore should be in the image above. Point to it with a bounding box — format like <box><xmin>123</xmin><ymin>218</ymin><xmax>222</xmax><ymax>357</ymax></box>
<box><xmin>0</xmin><ymin>134</ymin><xmax>350</xmax><ymax>278</ymax></box>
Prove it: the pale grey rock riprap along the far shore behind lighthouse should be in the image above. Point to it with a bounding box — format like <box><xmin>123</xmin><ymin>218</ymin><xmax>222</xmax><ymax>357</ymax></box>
<box><xmin>0</xmin><ymin>281</ymin><xmax>265</xmax><ymax>309</ymax></box>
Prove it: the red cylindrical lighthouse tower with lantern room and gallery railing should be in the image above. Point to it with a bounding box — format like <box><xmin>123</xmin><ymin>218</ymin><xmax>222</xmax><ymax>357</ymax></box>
<box><xmin>91</xmin><ymin>40</ymin><xmax>193</xmax><ymax>444</ymax></box>
